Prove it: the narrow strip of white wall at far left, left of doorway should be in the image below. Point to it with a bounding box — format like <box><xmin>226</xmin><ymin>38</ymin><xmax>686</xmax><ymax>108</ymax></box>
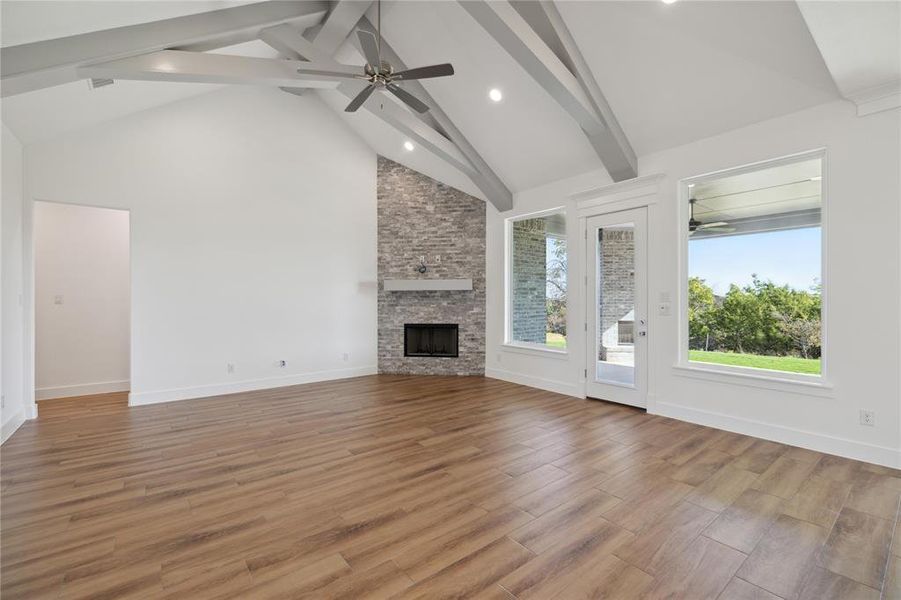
<box><xmin>0</xmin><ymin>125</ymin><xmax>31</xmax><ymax>441</ymax></box>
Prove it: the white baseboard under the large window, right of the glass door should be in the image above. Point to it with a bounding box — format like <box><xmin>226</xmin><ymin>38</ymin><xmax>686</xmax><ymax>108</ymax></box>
<box><xmin>648</xmin><ymin>400</ymin><xmax>901</xmax><ymax>469</ymax></box>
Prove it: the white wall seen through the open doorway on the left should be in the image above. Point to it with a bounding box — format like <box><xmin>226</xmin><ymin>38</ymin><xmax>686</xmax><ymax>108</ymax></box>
<box><xmin>33</xmin><ymin>202</ymin><xmax>130</xmax><ymax>400</ymax></box>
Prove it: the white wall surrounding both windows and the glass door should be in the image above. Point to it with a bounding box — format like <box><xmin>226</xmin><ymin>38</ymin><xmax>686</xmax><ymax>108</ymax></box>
<box><xmin>487</xmin><ymin>102</ymin><xmax>901</xmax><ymax>466</ymax></box>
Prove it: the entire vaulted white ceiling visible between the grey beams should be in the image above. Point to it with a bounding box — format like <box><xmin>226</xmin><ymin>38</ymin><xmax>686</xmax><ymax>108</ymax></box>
<box><xmin>0</xmin><ymin>0</ymin><xmax>888</xmax><ymax>195</ymax></box>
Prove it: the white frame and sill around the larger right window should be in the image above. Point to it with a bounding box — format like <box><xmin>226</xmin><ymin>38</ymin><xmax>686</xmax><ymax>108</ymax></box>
<box><xmin>673</xmin><ymin>148</ymin><xmax>832</xmax><ymax>390</ymax></box>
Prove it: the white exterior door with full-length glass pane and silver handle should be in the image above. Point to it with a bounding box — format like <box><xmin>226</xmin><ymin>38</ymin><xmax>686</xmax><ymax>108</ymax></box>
<box><xmin>585</xmin><ymin>207</ymin><xmax>648</xmax><ymax>408</ymax></box>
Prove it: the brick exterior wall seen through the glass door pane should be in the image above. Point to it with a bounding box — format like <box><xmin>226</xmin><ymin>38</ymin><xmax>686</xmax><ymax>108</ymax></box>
<box><xmin>598</xmin><ymin>229</ymin><xmax>635</xmax><ymax>360</ymax></box>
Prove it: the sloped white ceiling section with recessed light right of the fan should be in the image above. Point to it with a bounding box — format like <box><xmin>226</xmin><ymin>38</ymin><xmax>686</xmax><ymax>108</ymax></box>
<box><xmin>382</xmin><ymin>1</ymin><xmax>599</xmax><ymax>190</ymax></box>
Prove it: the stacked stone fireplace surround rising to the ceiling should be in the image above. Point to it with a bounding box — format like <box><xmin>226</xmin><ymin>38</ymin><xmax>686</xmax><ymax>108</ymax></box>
<box><xmin>378</xmin><ymin>156</ymin><xmax>485</xmax><ymax>375</ymax></box>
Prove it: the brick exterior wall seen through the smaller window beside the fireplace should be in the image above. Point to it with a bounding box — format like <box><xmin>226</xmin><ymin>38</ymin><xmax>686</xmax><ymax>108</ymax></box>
<box><xmin>510</xmin><ymin>218</ymin><xmax>547</xmax><ymax>344</ymax></box>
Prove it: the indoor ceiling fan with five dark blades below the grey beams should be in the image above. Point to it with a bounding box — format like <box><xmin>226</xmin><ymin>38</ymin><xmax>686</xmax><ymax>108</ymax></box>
<box><xmin>297</xmin><ymin>0</ymin><xmax>454</xmax><ymax>113</ymax></box>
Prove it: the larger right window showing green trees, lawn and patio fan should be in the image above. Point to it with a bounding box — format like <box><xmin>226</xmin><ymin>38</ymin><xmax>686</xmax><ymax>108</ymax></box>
<box><xmin>683</xmin><ymin>154</ymin><xmax>823</xmax><ymax>379</ymax></box>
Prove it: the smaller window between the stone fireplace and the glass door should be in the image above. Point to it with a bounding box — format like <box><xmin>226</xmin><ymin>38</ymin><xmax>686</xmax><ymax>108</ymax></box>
<box><xmin>507</xmin><ymin>212</ymin><xmax>566</xmax><ymax>350</ymax></box>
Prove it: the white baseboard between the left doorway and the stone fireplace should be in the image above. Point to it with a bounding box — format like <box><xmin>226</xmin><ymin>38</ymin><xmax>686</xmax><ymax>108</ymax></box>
<box><xmin>128</xmin><ymin>365</ymin><xmax>378</xmax><ymax>406</ymax></box>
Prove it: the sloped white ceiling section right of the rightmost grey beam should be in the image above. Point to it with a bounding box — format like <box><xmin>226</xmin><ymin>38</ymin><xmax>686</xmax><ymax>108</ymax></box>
<box><xmin>558</xmin><ymin>1</ymin><xmax>838</xmax><ymax>155</ymax></box>
